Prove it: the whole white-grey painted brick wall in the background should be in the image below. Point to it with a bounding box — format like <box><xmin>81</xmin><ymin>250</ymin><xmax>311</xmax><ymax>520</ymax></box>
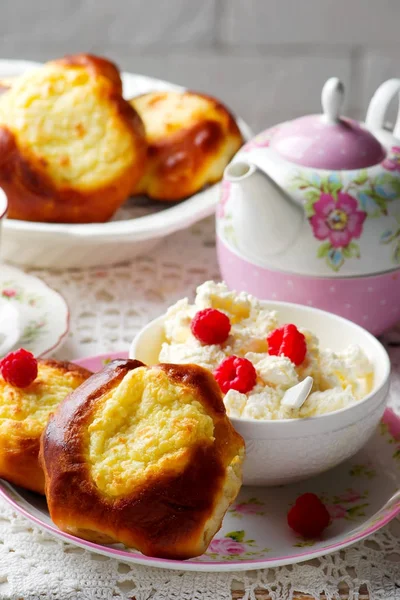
<box><xmin>0</xmin><ymin>0</ymin><xmax>400</xmax><ymax>134</ymax></box>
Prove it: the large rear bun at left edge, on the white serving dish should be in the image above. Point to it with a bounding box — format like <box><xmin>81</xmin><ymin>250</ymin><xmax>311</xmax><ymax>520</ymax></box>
<box><xmin>0</xmin><ymin>54</ymin><xmax>146</xmax><ymax>223</ymax></box>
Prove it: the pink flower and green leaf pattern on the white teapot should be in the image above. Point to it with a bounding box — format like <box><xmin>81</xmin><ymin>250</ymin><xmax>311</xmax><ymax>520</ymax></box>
<box><xmin>290</xmin><ymin>152</ymin><xmax>400</xmax><ymax>272</ymax></box>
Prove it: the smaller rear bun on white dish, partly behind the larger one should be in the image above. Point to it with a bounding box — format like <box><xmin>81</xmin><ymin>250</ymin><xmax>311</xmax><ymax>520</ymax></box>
<box><xmin>130</xmin><ymin>92</ymin><xmax>243</xmax><ymax>200</ymax></box>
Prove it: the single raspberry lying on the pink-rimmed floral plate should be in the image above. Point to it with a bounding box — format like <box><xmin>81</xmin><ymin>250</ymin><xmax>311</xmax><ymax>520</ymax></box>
<box><xmin>287</xmin><ymin>493</ymin><xmax>331</xmax><ymax>538</ymax></box>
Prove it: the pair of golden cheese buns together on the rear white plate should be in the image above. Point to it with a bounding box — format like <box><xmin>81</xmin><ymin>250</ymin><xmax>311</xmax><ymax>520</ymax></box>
<box><xmin>0</xmin><ymin>54</ymin><xmax>243</xmax><ymax>223</ymax></box>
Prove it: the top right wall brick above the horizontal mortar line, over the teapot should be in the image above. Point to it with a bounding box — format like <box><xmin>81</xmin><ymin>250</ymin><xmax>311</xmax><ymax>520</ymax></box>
<box><xmin>222</xmin><ymin>0</ymin><xmax>400</xmax><ymax>46</ymax></box>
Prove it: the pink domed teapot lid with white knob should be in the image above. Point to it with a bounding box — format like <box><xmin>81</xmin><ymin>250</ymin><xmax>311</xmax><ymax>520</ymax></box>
<box><xmin>270</xmin><ymin>77</ymin><xmax>386</xmax><ymax>171</ymax></box>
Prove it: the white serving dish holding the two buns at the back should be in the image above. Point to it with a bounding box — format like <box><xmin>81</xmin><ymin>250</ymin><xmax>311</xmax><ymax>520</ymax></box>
<box><xmin>0</xmin><ymin>60</ymin><xmax>253</xmax><ymax>269</ymax></box>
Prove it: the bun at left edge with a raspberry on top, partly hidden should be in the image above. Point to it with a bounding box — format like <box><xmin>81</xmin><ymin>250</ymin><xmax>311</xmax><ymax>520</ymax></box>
<box><xmin>0</xmin><ymin>359</ymin><xmax>91</xmax><ymax>494</ymax></box>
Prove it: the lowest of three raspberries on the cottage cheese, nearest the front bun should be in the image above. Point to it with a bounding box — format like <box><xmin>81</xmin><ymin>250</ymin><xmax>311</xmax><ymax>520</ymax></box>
<box><xmin>214</xmin><ymin>356</ymin><xmax>257</xmax><ymax>394</ymax></box>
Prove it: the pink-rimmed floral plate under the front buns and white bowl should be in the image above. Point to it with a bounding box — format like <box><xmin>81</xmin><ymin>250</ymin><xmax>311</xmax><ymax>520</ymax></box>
<box><xmin>0</xmin><ymin>352</ymin><xmax>400</xmax><ymax>572</ymax></box>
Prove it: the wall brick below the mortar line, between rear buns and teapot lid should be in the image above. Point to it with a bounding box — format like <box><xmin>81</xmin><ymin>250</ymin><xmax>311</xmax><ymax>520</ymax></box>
<box><xmin>121</xmin><ymin>51</ymin><xmax>350</xmax><ymax>129</ymax></box>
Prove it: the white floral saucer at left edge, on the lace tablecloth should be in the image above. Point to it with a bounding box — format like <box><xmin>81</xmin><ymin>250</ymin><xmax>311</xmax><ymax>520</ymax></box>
<box><xmin>0</xmin><ymin>265</ymin><xmax>69</xmax><ymax>357</ymax></box>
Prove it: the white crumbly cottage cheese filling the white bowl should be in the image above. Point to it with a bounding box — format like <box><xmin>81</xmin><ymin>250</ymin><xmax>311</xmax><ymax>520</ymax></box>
<box><xmin>158</xmin><ymin>281</ymin><xmax>374</xmax><ymax>420</ymax></box>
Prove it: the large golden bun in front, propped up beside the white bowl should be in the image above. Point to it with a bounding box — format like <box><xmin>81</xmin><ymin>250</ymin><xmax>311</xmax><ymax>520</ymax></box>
<box><xmin>40</xmin><ymin>360</ymin><xmax>244</xmax><ymax>559</ymax></box>
